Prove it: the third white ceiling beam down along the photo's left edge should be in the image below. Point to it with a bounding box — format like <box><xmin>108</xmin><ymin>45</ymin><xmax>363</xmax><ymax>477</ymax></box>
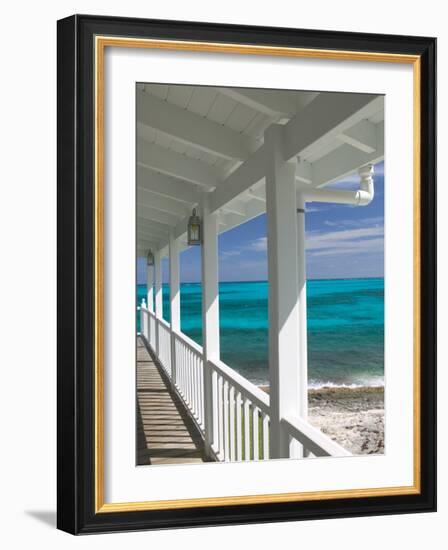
<box><xmin>137</xmin><ymin>166</ymin><xmax>201</xmax><ymax>205</ymax></box>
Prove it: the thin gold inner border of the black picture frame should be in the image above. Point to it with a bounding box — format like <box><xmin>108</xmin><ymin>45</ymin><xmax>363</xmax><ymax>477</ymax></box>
<box><xmin>94</xmin><ymin>36</ymin><xmax>421</xmax><ymax>513</ymax></box>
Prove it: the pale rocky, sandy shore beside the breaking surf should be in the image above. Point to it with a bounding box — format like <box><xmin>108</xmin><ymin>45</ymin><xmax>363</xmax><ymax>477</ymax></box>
<box><xmin>262</xmin><ymin>387</ymin><xmax>384</xmax><ymax>454</ymax></box>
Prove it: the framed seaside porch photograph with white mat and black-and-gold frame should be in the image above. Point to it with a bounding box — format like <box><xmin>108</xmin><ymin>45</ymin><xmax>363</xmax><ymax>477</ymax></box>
<box><xmin>58</xmin><ymin>15</ymin><xmax>436</xmax><ymax>534</ymax></box>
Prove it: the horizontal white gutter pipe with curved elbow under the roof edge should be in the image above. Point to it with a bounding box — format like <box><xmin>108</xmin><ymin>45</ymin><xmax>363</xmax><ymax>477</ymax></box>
<box><xmin>301</xmin><ymin>164</ymin><xmax>375</xmax><ymax>206</ymax></box>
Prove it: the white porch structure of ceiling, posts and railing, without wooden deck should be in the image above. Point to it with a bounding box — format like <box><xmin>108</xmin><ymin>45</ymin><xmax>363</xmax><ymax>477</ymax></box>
<box><xmin>137</xmin><ymin>84</ymin><xmax>384</xmax><ymax>461</ymax></box>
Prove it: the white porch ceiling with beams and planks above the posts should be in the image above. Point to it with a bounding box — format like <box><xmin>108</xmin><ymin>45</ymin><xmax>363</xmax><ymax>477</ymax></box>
<box><xmin>136</xmin><ymin>84</ymin><xmax>384</xmax><ymax>255</ymax></box>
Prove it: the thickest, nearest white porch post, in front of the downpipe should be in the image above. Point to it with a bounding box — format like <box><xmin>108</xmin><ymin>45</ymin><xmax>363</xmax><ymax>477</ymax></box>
<box><xmin>265</xmin><ymin>125</ymin><xmax>301</xmax><ymax>458</ymax></box>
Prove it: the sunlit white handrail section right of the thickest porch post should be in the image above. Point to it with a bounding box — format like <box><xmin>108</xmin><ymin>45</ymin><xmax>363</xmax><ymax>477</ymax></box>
<box><xmin>281</xmin><ymin>416</ymin><xmax>352</xmax><ymax>456</ymax></box>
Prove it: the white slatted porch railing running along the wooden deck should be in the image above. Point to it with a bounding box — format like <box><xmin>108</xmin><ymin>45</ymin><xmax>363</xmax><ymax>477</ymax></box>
<box><xmin>140</xmin><ymin>302</ymin><xmax>350</xmax><ymax>462</ymax></box>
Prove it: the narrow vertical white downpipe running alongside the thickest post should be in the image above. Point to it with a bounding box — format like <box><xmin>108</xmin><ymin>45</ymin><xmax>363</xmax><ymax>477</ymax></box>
<box><xmin>297</xmin><ymin>193</ymin><xmax>308</xmax><ymax>419</ymax></box>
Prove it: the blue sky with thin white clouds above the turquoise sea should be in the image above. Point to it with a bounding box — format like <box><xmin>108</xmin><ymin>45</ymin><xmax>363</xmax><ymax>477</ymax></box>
<box><xmin>137</xmin><ymin>162</ymin><xmax>384</xmax><ymax>283</ymax></box>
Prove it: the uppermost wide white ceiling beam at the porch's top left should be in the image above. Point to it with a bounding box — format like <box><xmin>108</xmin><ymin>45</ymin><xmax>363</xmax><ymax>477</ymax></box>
<box><xmin>137</xmin><ymin>92</ymin><xmax>256</xmax><ymax>160</ymax></box>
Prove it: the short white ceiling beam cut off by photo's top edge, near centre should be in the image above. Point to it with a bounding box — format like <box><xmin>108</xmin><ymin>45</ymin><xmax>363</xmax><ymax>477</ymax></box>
<box><xmin>217</xmin><ymin>88</ymin><xmax>297</xmax><ymax>118</ymax></box>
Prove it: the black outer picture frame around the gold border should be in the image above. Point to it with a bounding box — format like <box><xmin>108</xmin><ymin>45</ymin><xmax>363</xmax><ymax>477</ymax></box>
<box><xmin>57</xmin><ymin>15</ymin><xmax>436</xmax><ymax>534</ymax></box>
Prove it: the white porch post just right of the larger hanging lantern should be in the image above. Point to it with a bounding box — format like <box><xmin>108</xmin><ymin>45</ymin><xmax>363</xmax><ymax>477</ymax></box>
<box><xmin>201</xmin><ymin>195</ymin><xmax>220</xmax><ymax>455</ymax></box>
